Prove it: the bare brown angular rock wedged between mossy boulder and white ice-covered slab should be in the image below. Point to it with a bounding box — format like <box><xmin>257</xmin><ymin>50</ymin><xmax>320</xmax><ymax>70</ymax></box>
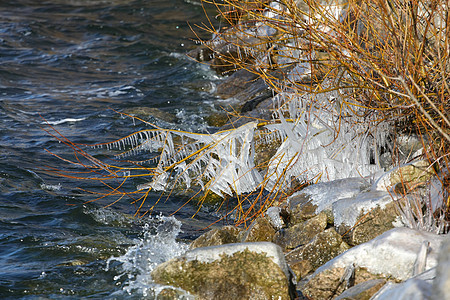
<box><xmin>286</xmin><ymin>228</ymin><xmax>350</xmax><ymax>270</ymax></box>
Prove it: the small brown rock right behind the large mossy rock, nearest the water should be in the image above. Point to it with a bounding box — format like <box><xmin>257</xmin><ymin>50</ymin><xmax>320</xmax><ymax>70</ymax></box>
<box><xmin>190</xmin><ymin>226</ymin><xmax>242</xmax><ymax>249</ymax></box>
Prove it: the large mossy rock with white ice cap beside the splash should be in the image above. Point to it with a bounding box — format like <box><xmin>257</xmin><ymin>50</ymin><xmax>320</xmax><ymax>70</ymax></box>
<box><xmin>151</xmin><ymin>242</ymin><xmax>295</xmax><ymax>299</ymax></box>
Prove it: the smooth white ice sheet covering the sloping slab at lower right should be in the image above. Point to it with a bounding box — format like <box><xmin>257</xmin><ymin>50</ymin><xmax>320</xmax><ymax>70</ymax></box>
<box><xmin>316</xmin><ymin>228</ymin><xmax>445</xmax><ymax>280</ymax></box>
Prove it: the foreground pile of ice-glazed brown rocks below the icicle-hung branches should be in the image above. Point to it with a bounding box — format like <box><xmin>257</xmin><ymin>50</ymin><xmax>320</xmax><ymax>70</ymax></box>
<box><xmin>151</xmin><ymin>175</ymin><xmax>450</xmax><ymax>299</ymax></box>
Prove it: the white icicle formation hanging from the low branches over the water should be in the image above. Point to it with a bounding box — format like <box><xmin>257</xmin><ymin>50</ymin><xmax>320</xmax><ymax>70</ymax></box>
<box><xmin>91</xmin><ymin>81</ymin><xmax>389</xmax><ymax>202</ymax></box>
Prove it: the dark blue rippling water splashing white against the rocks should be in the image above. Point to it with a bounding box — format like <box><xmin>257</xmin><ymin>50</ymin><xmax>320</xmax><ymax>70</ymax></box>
<box><xmin>0</xmin><ymin>0</ymin><xmax>225</xmax><ymax>299</ymax></box>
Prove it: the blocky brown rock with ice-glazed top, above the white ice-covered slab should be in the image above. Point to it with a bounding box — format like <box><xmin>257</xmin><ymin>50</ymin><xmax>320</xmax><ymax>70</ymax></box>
<box><xmin>333</xmin><ymin>191</ymin><xmax>400</xmax><ymax>245</ymax></box>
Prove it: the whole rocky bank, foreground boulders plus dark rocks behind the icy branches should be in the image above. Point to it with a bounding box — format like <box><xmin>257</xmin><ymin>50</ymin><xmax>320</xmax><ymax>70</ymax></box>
<box><xmin>146</xmin><ymin>4</ymin><xmax>450</xmax><ymax>300</ymax></box>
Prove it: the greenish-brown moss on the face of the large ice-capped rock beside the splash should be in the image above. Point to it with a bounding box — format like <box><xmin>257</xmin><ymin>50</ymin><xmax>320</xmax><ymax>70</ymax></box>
<box><xmin>151</xmin><ymin>249</ymin><xmax>290</xmax><ymax>299</ymax></box>
